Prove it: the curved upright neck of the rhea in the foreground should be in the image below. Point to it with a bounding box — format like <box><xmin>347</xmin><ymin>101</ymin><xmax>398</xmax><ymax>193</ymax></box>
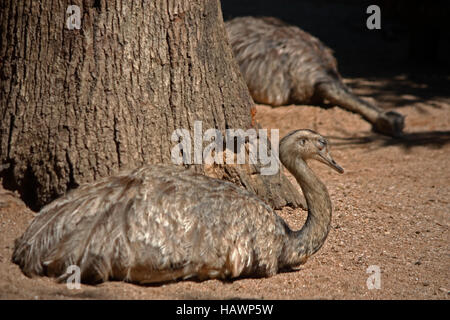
<box><xmin>285</xmin><ymin>158</ymin><xmax>332</xmax><ymax>265</ymax></box>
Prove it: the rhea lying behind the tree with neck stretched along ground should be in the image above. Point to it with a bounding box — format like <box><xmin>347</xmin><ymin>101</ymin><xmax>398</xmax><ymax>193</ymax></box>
<box><xmin>226</xmin><ymin>17</ymin><xmax>404</xmax><ymax>136</ymax></box>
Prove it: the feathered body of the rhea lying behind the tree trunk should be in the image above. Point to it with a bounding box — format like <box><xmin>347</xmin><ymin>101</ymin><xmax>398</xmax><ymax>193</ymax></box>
<box><xmin>226</xmin><ymin>17</ymin><xmax>340</xmax><ymax>106</ymax></box>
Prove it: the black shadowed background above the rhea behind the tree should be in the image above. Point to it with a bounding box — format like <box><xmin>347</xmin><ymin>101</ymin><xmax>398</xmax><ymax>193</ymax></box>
<box><xmin>222</xmin><ymin>0</ymin><xmax>450</xmax><ymax>78</ymax></box>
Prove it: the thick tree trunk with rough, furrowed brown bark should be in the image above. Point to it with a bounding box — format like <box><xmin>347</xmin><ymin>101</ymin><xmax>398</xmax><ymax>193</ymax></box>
<box><xmin>0</xmin><ymin>0</ymin><xmax>301</xmax><ymax>210</ymax></box>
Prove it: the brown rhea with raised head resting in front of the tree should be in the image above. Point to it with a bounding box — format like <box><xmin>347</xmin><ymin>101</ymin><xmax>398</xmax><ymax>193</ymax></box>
<box><xmin>13</xmin><ymin>130</ymin><xmax>343</xmax><ymax>283</ymax></box>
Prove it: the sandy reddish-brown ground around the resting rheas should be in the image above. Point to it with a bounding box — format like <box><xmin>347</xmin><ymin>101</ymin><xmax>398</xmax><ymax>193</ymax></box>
<box><xmin>0</xmin><ymin>72</ymin><xmax>450</xmax><ymax>299</ymax></box>
